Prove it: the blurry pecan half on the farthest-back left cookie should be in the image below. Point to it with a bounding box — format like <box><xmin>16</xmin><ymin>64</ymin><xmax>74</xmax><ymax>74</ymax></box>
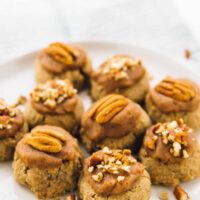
<box><xmin>46</xmin><ymin>42</ymin><xmax>77</xmax><ymax>65</ymax></box>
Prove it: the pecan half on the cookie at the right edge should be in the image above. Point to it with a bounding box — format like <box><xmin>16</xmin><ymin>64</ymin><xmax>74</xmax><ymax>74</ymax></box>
<box><xmin>155</xmin><ymin>77</ymin><xmax>195</xmax><ymax>102</ymax></box>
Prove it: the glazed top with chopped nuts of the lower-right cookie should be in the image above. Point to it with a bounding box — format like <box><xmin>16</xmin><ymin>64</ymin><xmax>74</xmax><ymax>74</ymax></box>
<box><xmin>144</xmin><ymin>119</ymin><xmax>197</xmax><ymax>163</ymax></box>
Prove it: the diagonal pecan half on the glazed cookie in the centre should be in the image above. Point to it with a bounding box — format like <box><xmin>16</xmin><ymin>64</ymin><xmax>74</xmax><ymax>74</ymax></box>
<box><xmin>88</xmin><ymin>94</ymin><xmax>128</xmax><ymax>123</ymax></box>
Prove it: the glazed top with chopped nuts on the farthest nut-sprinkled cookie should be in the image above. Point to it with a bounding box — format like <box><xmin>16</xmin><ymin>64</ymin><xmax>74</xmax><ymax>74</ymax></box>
<box><xmin>93</xmin><ymin>55</ymin><xmax>145</xmax><ymax>92</ymax></box>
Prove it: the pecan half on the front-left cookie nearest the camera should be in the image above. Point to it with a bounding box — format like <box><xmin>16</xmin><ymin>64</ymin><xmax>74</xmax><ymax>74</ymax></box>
<box><xmin>26</xmin><ymin>126</ymin><xmax>66</xmax><ymax>153</ymax></box>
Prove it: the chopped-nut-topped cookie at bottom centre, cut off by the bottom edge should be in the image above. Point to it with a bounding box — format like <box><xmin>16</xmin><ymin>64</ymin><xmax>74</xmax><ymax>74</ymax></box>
<box><xmin>78</xmin><ymin>147</ymin><xmax>151</xmax><ymax>200</ymax></box>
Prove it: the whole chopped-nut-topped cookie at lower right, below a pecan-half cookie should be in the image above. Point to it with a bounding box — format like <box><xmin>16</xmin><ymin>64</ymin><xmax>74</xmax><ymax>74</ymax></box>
<box><xmin>139</xmin><ymin>119</ymin><xmax>200</xmax><ymax>185</ymax></box>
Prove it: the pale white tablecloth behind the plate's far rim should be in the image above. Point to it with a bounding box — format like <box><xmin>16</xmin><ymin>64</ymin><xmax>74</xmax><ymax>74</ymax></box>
<box><xmin>0</xmin><ymin>0</ymin><xmax>199</xmax><ymax>71</ymax></box>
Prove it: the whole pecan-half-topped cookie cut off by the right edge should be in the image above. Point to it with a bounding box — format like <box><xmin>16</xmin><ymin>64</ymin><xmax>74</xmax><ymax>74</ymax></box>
<box><xmin>146</xmin><ymin>77</ymin><xmax>200</xmax><ymax>129</ymax></box>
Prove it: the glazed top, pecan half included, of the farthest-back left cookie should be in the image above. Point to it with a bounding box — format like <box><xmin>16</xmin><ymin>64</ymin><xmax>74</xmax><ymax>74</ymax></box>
<box><xmin>38</xmin><ymin>42</ymin><xmax>86</xmax><ymax>74</ymax></box>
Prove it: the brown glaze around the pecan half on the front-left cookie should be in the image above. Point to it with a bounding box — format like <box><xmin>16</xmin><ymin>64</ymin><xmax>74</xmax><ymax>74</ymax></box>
<box><xmin>16</xmin><ymin>125</ymin><xmax>82</xmax><ymax>169</ymax></box>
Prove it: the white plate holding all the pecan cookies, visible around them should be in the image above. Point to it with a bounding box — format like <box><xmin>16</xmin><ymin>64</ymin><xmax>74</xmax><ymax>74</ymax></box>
<box><xmin>0</xmin><ymin>42</ymin><xmax>200</xmax><ymax>200</ymax></box>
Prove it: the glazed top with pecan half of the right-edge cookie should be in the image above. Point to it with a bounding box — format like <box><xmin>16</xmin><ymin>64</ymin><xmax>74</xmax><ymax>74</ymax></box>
<box><xmin>149</xmin><ymin>77</ymin><xmax>200</xmax><ymax>112</ymax></box>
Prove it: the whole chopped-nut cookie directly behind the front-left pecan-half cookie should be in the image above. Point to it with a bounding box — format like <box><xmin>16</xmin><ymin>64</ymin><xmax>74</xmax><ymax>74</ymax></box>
<box><xmin>25</xmin><ymin>79</ymin><xmax>83</xmax><ymax>134</ymax></box>
